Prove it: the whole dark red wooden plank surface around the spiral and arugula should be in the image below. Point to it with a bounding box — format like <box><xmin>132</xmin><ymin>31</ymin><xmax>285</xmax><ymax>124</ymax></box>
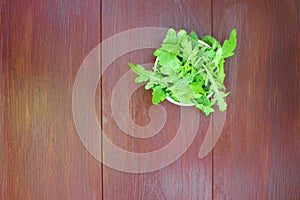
<box><xmin>0</xmin><ymin>0</ymin><xmax>300</xmax><ymax>200</ymax></box>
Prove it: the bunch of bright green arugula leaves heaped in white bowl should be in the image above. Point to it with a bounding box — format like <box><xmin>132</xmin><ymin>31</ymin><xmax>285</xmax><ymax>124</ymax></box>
<box><xmin>128</xmin><ymin>28</ymin><xmax>236</xmax><ymax>115</ymax></box>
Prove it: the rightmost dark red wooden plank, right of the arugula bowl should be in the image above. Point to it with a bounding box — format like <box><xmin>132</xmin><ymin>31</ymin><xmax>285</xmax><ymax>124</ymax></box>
<box><xmin>213</xmin><ymin>0</ymin><xmax>300</xmax><ymax>199</ymax></box>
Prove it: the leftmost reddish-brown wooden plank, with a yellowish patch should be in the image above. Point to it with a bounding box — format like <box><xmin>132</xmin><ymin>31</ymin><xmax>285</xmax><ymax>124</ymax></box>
<box><xmin>1</xmin><ymin>0</ymin><xmax>102</xmax><ymax>199</ymax></box>
